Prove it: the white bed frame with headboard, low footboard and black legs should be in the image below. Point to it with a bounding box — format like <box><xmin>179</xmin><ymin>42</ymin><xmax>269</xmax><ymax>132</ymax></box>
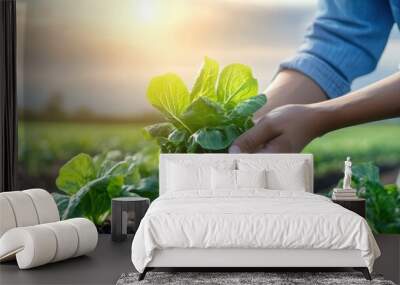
<box><xmin>139</xmin><ymin>154</ymin><xmax>371</xmax><ymax>280</ymax></box>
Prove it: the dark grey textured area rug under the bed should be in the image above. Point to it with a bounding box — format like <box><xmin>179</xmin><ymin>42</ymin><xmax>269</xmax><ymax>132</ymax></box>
<box><xmin>117</xmin><ymin>272</ymin><xmax>395</xmax><ymax>285</ymax></box>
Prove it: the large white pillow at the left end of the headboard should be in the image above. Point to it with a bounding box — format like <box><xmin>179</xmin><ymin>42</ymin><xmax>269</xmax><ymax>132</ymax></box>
<box><xmin>167</xmin><ymin>163</ymin><xmax>211</xmax><ymax>191</ymax></box>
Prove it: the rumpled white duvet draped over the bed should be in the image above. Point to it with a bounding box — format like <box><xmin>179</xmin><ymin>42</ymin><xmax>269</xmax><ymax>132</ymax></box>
<box><xmin>132</xmin><ymin>189</ymin><xmax>380</xmax><ymax>272</ymax></box>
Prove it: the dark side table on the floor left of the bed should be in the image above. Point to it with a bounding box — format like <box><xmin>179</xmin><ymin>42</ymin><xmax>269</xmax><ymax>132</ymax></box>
<box><xmin>111</xmin><ymin>197</ymin><xmax>150</xmax><ymax>241</ymax></box>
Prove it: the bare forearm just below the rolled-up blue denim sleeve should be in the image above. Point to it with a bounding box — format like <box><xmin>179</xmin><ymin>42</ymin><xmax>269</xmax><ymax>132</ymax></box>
<box><xmin>254</xmin><ymin>70</ymin><xmax>327</xmax><ymax>120</ymax></box>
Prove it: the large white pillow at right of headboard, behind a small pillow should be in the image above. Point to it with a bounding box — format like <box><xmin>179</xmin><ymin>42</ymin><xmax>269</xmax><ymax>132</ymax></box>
<box><xmin>238</xmin><ymin>159</ymin><xmax>309</xmax><ymax>191</ymax></box>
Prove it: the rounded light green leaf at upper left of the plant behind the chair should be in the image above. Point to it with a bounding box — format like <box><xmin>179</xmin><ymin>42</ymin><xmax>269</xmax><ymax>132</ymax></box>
<box><xmin>56</xmin><ymin>153</ymin><xmax>96</xmax><ymax>194</ymax></box>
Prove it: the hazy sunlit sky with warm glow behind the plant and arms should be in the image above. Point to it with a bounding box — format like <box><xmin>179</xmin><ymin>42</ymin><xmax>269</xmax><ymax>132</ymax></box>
<box><xmin>17</xmin><ymin>0</ymin><xmax>400</xmax><ymax>116</ymax></box>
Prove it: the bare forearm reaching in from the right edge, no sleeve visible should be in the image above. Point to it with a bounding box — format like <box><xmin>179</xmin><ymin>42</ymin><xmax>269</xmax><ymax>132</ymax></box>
<box><xmin>310</xmin><ymin>70</ymin><xmax>400</xmax><ymax>135</ymax></box>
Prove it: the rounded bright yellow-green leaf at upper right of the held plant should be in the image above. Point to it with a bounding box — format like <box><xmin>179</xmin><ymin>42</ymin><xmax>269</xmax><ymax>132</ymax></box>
<box><xmin>217</xmin><ymin>64</ymin><xmax>258</xmax><ymax>108</ymax></box>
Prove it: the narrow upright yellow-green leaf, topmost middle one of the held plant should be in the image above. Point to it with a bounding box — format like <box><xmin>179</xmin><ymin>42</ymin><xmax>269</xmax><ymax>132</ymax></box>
<box><xmin>190</xmin><ymin>57</ymin><xmax>219</xmax><ymax>101</ymax></box>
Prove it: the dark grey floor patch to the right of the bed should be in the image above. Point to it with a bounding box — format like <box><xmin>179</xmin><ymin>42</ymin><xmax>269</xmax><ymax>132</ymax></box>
<box><xmin>374</xmin><ymin>234</ymin><xmax>400</xmax><ymax>284</ymax></box>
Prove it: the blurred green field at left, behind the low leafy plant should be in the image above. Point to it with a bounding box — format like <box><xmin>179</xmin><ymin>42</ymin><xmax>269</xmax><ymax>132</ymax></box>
<box><xmin>18</xmin><ymin>122</ymin><xmax>149</xmax><ymax>175</ymax></box>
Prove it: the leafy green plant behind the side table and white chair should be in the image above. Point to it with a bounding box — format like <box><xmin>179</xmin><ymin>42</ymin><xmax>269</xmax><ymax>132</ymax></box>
<box><xmin>53</xmin><ymin>147</ymin><xmax>158</xmax><ymax>225</ymax></box>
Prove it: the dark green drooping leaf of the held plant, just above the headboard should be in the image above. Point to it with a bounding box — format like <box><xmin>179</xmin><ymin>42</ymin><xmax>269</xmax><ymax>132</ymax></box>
<box><xmin>193</xmin><ymin>125</ymin><xmax>240</xmax><ymax>150</ymax></box>
